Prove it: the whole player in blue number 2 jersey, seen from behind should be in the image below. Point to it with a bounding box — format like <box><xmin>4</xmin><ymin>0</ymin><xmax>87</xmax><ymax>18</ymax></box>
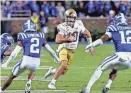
<box><xmin>1</xmin><ymin>20</ymin><xmax>59</xmax><ymax>93</ymax></box>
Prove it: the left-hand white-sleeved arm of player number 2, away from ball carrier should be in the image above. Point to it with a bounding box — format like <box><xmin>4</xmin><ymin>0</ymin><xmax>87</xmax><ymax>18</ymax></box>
<box><xmin>3</xmin><ymin>41</ymin><xmax>22</xmax><ymax>67</ymax></box>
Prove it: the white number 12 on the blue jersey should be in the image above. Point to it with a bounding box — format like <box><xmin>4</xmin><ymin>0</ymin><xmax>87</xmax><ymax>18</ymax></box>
<box><xmin>119</xmin><ymin>30</ymin><xmax>131</xmax><ymax>44</ymax></box>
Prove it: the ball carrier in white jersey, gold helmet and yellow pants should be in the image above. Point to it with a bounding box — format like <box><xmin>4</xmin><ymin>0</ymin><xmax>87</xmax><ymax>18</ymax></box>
<box><xmin>45</xmin><ymin>9</ymin><xmax>94</xmax><ymax>89</ymax></box>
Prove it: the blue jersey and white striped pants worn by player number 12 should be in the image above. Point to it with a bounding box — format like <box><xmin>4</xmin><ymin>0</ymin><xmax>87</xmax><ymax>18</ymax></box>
<box><xmin>100</xmin><ymin>25</ymin><xmax>131</xmax><ymax>70</ymax></box>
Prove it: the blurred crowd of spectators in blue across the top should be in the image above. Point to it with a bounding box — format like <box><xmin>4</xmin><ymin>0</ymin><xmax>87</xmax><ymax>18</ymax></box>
<box><xmin>1</xmin><ymin>0</ymin><xmax>131</xmax><ymax>18</ymax></box>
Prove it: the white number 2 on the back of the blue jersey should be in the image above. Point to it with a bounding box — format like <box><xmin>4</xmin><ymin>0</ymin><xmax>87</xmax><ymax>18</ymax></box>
<box><xmin>30</xmin><ymin>38</ymin><xmax>39</xmax><ymax>53</ymax></box>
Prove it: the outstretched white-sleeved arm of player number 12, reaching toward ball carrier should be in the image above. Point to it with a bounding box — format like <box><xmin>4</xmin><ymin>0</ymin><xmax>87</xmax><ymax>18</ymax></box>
<box><xmin>85</xmin><ymin>34</ymin><xmax>110</xmax><ymax>50</ymax></box>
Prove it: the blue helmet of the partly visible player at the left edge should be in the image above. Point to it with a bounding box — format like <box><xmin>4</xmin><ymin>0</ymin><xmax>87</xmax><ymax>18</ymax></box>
<box><xmin>0</xmin><ymin>33</ymin><xmax>14</xmax><ymax>45</ymax></box>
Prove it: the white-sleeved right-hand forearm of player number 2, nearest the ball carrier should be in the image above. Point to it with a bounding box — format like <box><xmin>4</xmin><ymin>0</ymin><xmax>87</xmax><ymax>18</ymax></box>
<box><xmin>44</xmin><ymin>42</ymin><xmax>60</xmax><ymax>62</ymax></box>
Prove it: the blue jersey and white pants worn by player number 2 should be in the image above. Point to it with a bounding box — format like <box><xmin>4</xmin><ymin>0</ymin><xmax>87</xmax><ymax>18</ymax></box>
<box><xmin>12</xmin><ymin>32</ymin><xmax>45</xmax><ymax>76</ymax></box>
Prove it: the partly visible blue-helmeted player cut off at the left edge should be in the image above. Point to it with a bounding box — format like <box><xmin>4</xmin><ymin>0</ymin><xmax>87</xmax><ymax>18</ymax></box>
<box><xmin>0</xmin><ymin>33</ymin><xmax>14</xmax><ymax>63</ymax></box>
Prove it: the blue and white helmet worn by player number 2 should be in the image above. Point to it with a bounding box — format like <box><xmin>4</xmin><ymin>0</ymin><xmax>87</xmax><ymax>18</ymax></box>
<box><xmin>22</xmin><ymin>19</ymin><xmax>37</xmax><ymax>32</ymax></box>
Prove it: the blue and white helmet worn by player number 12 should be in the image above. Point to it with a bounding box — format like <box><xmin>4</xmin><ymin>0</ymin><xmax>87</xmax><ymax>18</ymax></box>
<box><xmin>113</xmin><ymin>13</ymin><xmax>128</xmax><ymax>25</ymax></box>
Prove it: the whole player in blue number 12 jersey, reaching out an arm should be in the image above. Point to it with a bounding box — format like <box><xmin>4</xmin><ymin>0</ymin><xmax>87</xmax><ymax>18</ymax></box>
<box><xmin>80</xmin><ymin>13</ymin><xmax>131</xmax><ymax>93</ymax></box>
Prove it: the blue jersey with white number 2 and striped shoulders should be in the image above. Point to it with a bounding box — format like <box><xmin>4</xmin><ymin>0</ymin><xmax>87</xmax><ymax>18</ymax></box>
<box><xmin>17</xmin><ymin>32</ymin><xmax>45</xmax><ymax>58</ymax></box>
